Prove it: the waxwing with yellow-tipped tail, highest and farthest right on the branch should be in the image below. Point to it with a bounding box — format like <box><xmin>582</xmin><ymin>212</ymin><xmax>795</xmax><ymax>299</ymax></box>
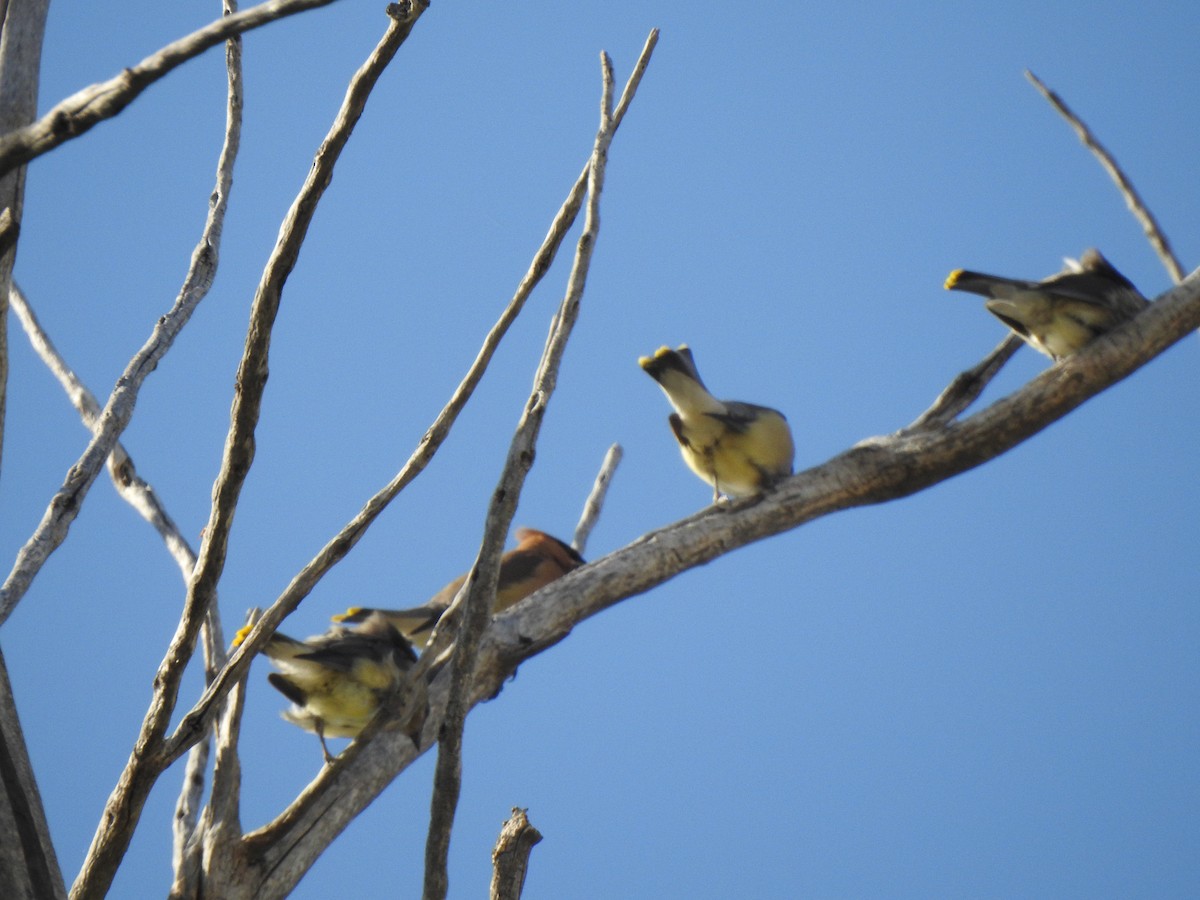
<box><xmin>946</xmin><ymin>248</ymin><xmax>1147</xmax><ymax>361</ymax></box>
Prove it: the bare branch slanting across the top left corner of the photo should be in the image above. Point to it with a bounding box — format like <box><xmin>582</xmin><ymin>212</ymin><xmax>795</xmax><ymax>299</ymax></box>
<box><xmin>0</xmin><ymin>0</ymin><xmax>350</xmax><ymax>181</ymax></box>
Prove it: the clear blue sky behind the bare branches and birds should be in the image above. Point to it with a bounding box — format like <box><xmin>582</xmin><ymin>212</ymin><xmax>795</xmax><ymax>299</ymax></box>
<box><xmin>0</xmin><ymin>0</ymin><xmax>1200</xmax><ymax>900</ymax></box>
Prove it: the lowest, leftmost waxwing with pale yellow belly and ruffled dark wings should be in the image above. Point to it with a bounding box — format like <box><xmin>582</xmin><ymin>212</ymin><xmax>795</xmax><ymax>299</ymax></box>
<box><xmin>233</xmin><ymin>616</ymin><xmax>416</xmax><ymax>762</ymax></box>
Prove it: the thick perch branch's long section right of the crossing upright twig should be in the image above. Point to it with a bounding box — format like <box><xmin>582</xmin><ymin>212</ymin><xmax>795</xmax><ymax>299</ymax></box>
<box><xmin>482</xmin><ymin>271</ymin><xmax>1200</xmax><ymax>681</ymax></box>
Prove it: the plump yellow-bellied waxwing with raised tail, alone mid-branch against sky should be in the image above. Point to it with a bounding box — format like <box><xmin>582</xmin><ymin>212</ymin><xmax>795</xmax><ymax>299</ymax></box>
<box><xmin>637</xmin><ymin>344</ymin><xmax>796</xmax><ymax>503</ymax></box>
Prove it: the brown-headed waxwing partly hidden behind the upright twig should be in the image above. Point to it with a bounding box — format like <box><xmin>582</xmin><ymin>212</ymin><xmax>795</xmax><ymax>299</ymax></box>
<box><xmin>334</xmin><ymin>528</ymin><xmax>583</xmax><ymax>650</ymax></box>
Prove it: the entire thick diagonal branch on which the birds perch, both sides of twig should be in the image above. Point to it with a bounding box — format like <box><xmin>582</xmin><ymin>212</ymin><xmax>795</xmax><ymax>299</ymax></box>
<box><xmin>234</xmin><ymin>262</ymin><xmax>1200</xmax><ymax>896</ymax></box>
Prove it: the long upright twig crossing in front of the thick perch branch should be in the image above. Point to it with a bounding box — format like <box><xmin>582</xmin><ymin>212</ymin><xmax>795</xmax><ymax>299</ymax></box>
<box><xmin>422</xmin><ymin>53</ymin><xmax>613</xmax><ymax>900</ymax></box>
